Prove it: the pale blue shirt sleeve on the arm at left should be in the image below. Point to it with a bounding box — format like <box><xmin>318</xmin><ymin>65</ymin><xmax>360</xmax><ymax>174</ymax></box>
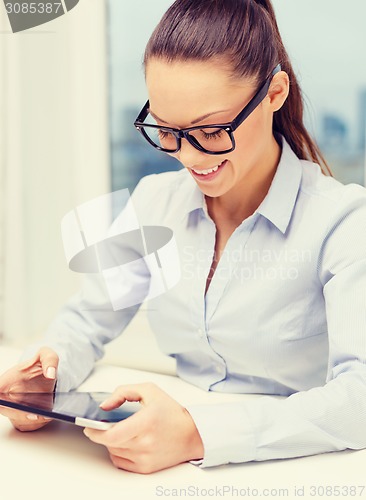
<box><xmin>22</xmin><ymin>180</ymin><xmax>156</xmax><ymax>391</ymax></box>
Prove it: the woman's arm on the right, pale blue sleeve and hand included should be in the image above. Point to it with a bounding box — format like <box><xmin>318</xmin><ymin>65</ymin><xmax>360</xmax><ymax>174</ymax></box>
<box><xmin>82</xmin><ymin>188</ymin><xmax>366</xmax><ymax>472</ymax></box>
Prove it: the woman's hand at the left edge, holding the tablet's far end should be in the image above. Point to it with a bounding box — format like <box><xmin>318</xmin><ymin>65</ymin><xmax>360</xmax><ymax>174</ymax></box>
<box><xmin>0</xmin><ymin>347</ymin><xmax>58</xmax><ymax>431</ymax></box>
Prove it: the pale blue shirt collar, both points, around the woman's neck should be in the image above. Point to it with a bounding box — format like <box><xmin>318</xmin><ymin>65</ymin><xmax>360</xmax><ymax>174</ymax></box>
<box><xmin>182</xmin><ymin>137</ymin><xmax>302</xmax><ymax>233</ymax></box>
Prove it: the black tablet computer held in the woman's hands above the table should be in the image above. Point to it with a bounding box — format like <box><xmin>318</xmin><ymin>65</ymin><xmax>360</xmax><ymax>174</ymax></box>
<box><xmin>0</xmin><ymin>391</ymin><xmax>140</xmax><ymax>430</ymax></box>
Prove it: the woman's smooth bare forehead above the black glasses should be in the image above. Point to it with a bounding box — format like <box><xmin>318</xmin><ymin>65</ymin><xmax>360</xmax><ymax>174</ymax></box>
<box><xmin>146</xmin><ymin>59</ymin><xmax>253</xmax><ymax>127</ymax></box>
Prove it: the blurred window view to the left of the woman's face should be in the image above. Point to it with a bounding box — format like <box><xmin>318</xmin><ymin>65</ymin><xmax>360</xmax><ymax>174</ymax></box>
<box><xmin>108</xmin><ymin>0</ymin><xmax>181</xmax><ymax>195</ymax></box>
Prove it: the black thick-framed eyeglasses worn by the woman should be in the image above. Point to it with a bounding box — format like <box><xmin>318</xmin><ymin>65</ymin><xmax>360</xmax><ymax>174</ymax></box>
<box><xmin>134</xmin><ymin>64</ymin><xmax>281</xmax><ymax>155</ymax></box>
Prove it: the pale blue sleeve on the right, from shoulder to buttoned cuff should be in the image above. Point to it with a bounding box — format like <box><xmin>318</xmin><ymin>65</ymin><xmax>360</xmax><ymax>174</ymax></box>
<box><xmin>188</xmin><ymin>189</ymin><xmax>366</xmax><ymax>467</ymax></box>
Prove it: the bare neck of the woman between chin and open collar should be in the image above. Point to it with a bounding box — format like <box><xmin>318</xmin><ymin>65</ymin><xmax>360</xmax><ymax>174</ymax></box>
<box><xmin>206</xmin><ymin>137</ymin><xmax>281</xmax><ymax>226</ymax></box>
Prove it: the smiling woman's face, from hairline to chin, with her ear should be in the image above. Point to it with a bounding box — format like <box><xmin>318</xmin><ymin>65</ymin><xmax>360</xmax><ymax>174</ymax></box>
<box><xmin>137</xmin><ymin>56</ymin><xmax>288</xmax><ymax>217</ymax></box>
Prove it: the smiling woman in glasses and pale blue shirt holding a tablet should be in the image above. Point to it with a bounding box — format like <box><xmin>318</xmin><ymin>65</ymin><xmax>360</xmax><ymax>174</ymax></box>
<box><xmin>0</xmin><ymin>0</ymin><xmax>366</xmax><ymax>473</ymax></box>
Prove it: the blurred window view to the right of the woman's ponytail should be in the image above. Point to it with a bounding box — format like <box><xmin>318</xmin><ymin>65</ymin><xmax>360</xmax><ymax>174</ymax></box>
<box><xmin>274</xmin><ymin>0</ymin><xmax>366</xmax><ymax>185</ymax></box>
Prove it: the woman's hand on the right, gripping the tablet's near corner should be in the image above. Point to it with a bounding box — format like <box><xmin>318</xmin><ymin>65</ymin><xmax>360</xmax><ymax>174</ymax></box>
<box><xmin>84</xmin><ymin>383</ymin><xmax>203</xmax><ymax>474</ymax></box>
